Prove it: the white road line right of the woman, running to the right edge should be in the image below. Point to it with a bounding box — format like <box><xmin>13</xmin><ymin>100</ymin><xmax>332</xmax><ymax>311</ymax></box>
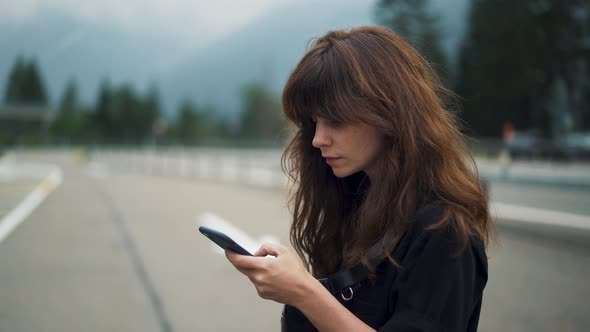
<box><xmin>490</xmin><ymin>202</ymin><xmax>590</xmax><ymax>231</ymax></box>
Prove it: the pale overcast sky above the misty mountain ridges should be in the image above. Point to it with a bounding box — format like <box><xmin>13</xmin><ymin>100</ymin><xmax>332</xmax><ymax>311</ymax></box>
<box><xmin>0</xmin><ymin>0</ymin><xmax>295</xmax><ymax>41</ymax></box>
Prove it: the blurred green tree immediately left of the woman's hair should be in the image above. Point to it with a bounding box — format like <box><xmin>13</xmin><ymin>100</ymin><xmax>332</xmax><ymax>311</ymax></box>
<box><xmin>241</xmin><ymin>83</ymin><xmax>286</xmax><ymax>142</ymax></box>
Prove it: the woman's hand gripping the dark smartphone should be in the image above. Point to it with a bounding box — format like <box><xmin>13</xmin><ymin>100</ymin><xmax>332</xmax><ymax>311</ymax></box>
<box><xmin>225</xmin><ymin>243</ymin><xmax>318</xmax><ymax>306</ymax></box>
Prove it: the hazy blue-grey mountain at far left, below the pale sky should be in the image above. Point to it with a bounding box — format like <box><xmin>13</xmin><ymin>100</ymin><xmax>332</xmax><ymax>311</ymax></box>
<box><xmin>0</xmin><ymin>11</ymin><xmax>200</xmax><ymax>104</ymax></box>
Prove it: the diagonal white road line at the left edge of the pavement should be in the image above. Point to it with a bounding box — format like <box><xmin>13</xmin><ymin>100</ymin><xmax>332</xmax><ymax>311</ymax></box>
<box><xmin>0</xmin><ymin>166</ymin><xmax>63</xmax><ymax>243</ymax></box>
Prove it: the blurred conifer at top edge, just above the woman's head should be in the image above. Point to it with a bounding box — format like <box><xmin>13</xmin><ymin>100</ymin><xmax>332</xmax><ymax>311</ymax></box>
<box><xmin>376</xmin><ymin>0</ymin><xmax>449</xmax><ymax>79</ymax></box>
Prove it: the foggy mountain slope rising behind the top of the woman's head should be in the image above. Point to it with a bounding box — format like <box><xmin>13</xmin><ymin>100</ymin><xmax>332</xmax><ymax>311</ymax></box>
<box><xmin>159</xmin><ymin>0</ymin><xmax>467</xmax><ymax>114</ymax></box>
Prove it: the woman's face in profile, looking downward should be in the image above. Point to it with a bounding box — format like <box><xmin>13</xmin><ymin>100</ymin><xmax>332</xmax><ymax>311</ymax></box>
<box><xmin>312</xmin><ymin>117</ymin><xmax>384</xmax><ymax>179</ymax></box>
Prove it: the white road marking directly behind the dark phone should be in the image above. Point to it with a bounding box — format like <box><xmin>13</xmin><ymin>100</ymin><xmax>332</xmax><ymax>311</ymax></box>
<box><xmin>198</xmin><ymin>212</ymin><xmax>279</xmax><ymax>254</ymax></box>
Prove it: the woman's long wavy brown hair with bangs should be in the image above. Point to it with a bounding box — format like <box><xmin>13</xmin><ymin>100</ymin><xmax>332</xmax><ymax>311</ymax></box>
<box><xmin>282</xmin><ymin>26</ymin><xmax>492</xmax><ymax>278</ymax></box>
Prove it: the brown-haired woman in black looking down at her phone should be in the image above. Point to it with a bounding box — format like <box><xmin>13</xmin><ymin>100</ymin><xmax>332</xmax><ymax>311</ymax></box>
<box><xmin>226</xmin><ymin>27</ymin><xmax>492</xmax><ymax>331</ymax></box>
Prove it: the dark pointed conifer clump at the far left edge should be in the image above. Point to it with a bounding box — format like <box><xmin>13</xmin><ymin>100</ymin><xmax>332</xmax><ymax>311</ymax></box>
<box><xmin>4</xmin><ymin>56</ymin><xmax>48</xmax><ymax>105</ymax></box>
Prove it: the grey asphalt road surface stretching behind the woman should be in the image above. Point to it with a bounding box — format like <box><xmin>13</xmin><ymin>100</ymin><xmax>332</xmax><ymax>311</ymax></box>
<box><xmin>0</xmin><ymin>157</ymin><xmax>590</xmax><ymax>332</ymax></box>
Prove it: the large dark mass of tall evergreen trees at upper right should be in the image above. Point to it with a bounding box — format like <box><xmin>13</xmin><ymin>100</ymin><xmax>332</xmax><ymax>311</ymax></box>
<box><xmin>456</xmin><ymin>0</ymin><xmax>590</xmax><ymax>136</ymax></box>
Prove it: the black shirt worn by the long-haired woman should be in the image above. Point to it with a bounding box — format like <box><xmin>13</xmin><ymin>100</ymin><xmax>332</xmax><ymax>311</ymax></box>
<box><xmin>283</xmin><ymin>209</ymin><xmax>488</xmax><ymax>332</ymax></box>
